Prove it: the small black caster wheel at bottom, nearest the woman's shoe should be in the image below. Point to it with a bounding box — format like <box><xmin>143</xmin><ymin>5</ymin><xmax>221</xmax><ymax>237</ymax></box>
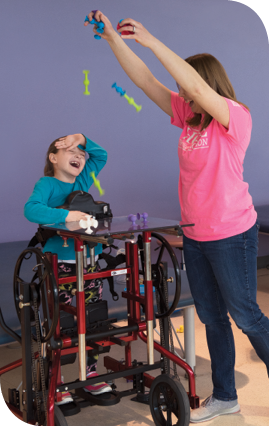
<box><xmin>149</xmin><ymin>374</ymin><xmax>190</xmax><ymax>426</ymax></box>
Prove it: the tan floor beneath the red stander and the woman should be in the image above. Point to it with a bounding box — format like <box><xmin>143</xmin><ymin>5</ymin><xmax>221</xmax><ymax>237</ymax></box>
<box><xmin>0</xmin><ymin>269</ymin><xmax>269</xmax><ymax>426</ymax></box>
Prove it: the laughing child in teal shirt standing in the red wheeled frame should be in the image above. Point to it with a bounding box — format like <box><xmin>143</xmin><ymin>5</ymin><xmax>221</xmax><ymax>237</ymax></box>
<box><xmin>24</xmin><ymin>134</ymin><xmax>112</xmax><ymax>404</ymax></box>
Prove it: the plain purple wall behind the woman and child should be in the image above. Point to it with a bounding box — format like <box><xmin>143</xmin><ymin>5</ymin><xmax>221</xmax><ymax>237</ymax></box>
<box><xmin>0</xmin><ymin>0</ymin><xmax>269</xmax><ymax>248</ymax></box>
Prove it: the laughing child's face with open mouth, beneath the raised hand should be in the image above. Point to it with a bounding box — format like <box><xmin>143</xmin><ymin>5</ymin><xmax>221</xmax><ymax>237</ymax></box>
<box><xmin>49</xmin><ymin>147</ymin><xmax>85</xmax><ymax>183</ymax></box>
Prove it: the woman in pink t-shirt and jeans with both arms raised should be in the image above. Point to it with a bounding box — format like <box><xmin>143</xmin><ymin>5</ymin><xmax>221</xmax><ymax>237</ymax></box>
<box><xmin>85</xmin><ymin>11</ymin><xmax>269</xmax><ymax>423</ymax></box>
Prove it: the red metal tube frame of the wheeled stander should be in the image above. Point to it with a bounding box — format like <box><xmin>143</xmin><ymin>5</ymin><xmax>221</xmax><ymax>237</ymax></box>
<box><xmin>0</xmin><ymin>231</ymin><xmax>199</xmax><ymax>426</ymax></box>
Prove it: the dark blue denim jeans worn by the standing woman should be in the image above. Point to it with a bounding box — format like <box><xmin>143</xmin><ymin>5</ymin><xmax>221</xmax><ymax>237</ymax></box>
<box><xmin>183</xmin><ymin>223</ymin><xmax>269</xmax><ymax>401</ymax></box>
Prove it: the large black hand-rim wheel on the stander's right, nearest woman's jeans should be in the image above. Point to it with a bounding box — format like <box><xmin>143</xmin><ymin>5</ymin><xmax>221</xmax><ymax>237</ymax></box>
<box><xmin>138</xmin><ymin>232</ymin><xmax>181</xmax><ymax>318</ymax></box>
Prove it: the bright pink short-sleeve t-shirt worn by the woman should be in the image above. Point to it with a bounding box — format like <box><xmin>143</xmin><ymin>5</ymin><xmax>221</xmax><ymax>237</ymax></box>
<box><xmin>171</xmin><ymin>92</ymin><xmax>257</xmax><ymax>241</ymax></box>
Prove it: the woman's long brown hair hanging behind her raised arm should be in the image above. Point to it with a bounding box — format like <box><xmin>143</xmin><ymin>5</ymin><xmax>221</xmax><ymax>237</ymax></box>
<box><xmin>181</xmin><ymin>53</ymin><xmax>249</xmax><ymax>130</ymax></box>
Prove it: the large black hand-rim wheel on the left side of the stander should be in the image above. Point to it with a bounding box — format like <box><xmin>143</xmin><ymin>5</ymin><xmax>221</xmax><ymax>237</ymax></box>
<box><xmin>13</xmin><ymin>248</ymin><xmax>59</xmax><ymax>342</ymax></box>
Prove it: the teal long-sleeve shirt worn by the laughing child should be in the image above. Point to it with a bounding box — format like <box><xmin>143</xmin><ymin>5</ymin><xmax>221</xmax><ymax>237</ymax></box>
<box><xmin>24</xmin><ymin>138</ymin><xmax>107</xmax><ymax>261</ymax></box>
